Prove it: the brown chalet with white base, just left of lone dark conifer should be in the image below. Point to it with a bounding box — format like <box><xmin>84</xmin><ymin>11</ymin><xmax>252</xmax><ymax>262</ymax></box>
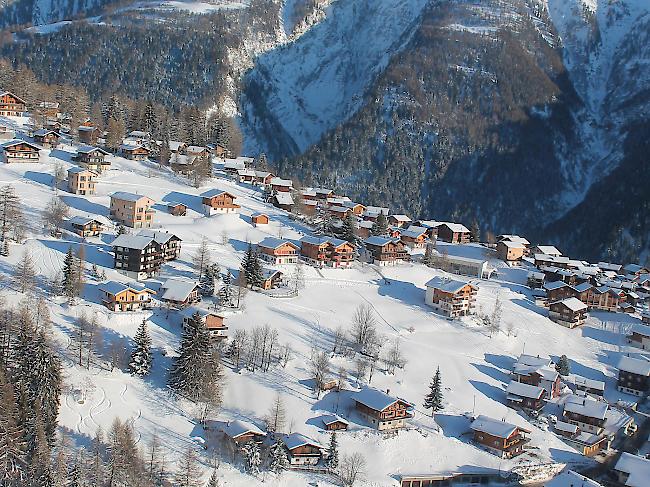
<box><xmin>352</xmin><ymin>387</ymin><xmax>413</xmax><ymax>431</ymax></box>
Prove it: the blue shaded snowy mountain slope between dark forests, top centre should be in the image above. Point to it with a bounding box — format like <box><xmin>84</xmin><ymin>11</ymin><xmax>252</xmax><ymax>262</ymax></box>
<box><xmin>242</xmin><ymin>0</ymin><xmax>427</xmax><ymax>156</ymax></box>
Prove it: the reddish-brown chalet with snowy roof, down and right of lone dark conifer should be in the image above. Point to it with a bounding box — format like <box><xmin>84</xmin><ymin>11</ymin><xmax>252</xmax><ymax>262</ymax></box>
<box><xmin>471</xmin><ymin>415</ymin><xmax>530</xmax><ymax>458</ymax></box>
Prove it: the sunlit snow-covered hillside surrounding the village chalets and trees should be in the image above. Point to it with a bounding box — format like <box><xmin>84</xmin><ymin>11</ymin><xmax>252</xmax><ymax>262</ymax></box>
<box><xmin>0</xmin><ymin>117</ymin><xmax>636</xmax><ymax>487</ymax></box>
